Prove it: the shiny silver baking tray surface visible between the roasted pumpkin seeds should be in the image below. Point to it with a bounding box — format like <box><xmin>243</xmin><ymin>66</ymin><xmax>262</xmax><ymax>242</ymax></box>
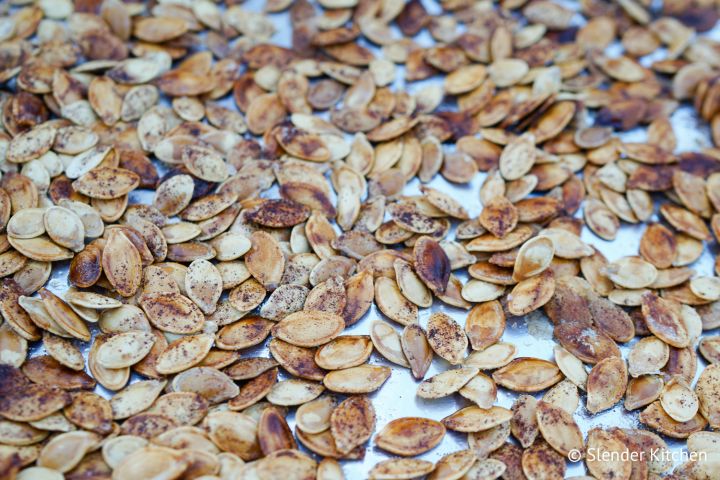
<box><xmin>25</xmin><ymin>0</ymin><xmax>720</xmax><ymax>479</ymax></box>
